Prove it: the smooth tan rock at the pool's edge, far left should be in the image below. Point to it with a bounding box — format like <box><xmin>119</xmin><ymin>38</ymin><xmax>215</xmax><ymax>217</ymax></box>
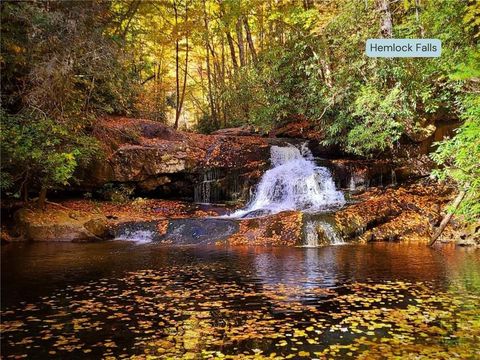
<box><xmin>14</xmin><ymin>208</ymin><xmax>108</xmax><ymax>242</ymax></box>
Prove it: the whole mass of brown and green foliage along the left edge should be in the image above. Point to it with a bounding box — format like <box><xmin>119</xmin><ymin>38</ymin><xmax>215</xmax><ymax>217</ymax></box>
<box><xmin>0</xmin><ymin>1</ymin><xmax>137</xmax><ymax>197</ymax></box>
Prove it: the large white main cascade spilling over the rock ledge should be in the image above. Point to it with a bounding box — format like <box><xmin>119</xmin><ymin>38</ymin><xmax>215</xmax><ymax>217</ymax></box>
<box><xmin>231</xmin><ymin>143</ymin><xmax>345</xmax><ymax>217</ymax></box>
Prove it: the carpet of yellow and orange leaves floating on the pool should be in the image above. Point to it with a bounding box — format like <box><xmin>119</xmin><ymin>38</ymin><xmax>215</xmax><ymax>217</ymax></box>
<box><xmin>2</xmin><ymin>243</ymin><xmax>480</xmax><ymax>359</ymax></box>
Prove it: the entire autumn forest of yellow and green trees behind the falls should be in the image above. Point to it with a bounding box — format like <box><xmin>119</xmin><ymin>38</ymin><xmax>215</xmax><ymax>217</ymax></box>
<box><xmin>0</xmin><ymin>0</ymin><xmax>480</xmax><ymax>219</ymax></box>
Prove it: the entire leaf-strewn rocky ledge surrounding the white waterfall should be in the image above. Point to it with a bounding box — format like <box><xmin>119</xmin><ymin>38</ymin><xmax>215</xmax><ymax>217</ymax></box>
<box><xmin>2</xmin><ymin>118</ymin><xmax>478</xmax><ymax>246</ymax></box>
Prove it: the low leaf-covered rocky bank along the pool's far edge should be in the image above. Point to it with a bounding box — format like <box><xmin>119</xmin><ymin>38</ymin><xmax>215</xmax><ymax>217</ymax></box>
<box><xmin>3</xmin><ymin>180</ymin><xmax>478</xmax><ymax>246</ymax></box>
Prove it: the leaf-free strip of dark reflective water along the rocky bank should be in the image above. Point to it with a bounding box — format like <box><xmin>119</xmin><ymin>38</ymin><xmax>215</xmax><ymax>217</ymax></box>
<box><xmin>2</xmin><ymin>241</ymin><xmax>480</xmax><ymax>305</ymax></box>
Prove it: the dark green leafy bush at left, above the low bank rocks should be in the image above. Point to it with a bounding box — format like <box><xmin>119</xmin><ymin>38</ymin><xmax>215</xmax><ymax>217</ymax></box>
<box><xmin>0</xmin><ymin>111</ymin><xmax>98</xmax><ymax>197</ymax></box>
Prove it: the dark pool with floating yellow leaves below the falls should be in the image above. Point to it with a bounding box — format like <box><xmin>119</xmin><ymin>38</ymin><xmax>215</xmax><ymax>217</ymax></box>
<box><xmin>1</xmin><ymin>241</ymin><xmax>480</xmax><ymax>359</ymax></box>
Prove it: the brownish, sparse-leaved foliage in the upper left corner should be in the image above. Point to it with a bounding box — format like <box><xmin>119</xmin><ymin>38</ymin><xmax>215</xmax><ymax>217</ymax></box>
<box><xmin>2</xmin><ymin>2</ymin><xmax>138</xmax><ymax>119</ymax></box>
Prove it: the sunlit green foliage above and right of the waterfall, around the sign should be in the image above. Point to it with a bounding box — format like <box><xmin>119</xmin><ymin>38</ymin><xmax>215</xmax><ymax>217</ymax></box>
<box><xmin>214</xmin><ymin>0</ymin><xmax>478</xmax><ymax>157</ymax></box>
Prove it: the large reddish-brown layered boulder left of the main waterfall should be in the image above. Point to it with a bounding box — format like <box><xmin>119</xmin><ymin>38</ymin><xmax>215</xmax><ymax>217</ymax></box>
<box><xmin>77</xmin><ymin>118</ymin><xmax>294</xmax><ymax>202</ymax></box>
